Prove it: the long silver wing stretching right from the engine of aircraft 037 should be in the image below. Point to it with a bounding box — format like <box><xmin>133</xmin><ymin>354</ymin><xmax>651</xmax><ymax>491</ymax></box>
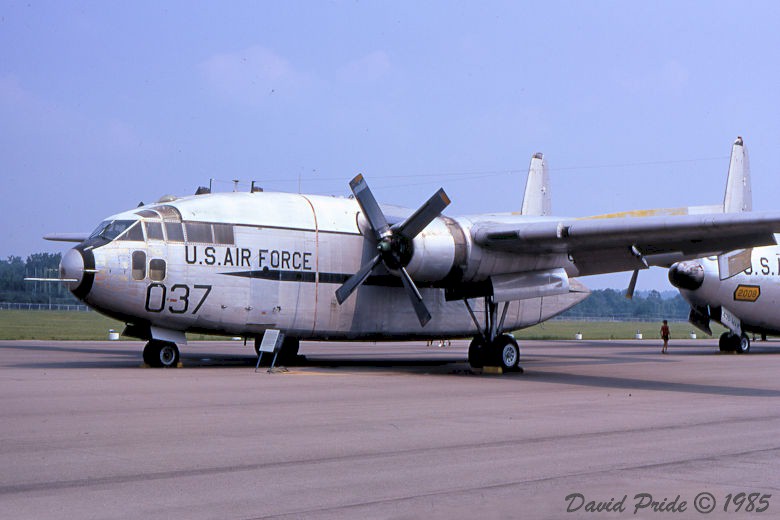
<box><xmin>472</xmin><ymin>212</ymin><xmax>780</xmax><ymax>275</ymax></box>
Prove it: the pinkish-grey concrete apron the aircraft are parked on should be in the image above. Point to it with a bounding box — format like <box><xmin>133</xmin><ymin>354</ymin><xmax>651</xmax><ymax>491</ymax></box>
<box><xmin>0</xmin><ymin>340</ymin><xmax>780</xmax><ymax>519</ymax></box>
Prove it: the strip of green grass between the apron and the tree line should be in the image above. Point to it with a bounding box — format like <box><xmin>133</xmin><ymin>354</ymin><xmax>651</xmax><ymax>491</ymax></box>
<box><xmin>0</xmin><ymin>310</ymin><xmax>725</xmax><ymax>341</ymax></box>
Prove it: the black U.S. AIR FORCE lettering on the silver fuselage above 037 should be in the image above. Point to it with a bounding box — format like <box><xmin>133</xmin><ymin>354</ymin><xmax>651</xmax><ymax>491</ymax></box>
<box><xmin>184</xmin><ymin>245</ymin><xmax>313</xmax><ymax>271</ymax></box>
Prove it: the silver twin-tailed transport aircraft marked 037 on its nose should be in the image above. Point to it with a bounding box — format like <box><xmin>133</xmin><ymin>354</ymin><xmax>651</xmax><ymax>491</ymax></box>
<box><xmin>45</xmin><ymin>141</ymin><xmax>780</xmax><ymax>370</ymax></box>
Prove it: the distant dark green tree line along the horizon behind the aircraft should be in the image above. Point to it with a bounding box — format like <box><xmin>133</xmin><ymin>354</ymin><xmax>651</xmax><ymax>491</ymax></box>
<box><xmin>0</xmin><ymin>253</ymin><xmax>689</xmax><ymax>320</ymax></box>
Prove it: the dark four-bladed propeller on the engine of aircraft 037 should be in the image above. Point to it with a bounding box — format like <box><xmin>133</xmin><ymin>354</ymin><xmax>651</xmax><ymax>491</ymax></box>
<box><xmin>336</xmin><ymin>174</ymin><xmax>450</xmax><ymax>326</ymax></box>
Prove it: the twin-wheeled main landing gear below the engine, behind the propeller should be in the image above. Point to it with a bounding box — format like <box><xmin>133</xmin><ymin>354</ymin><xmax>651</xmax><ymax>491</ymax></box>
<box><xmin>463</xmin><ymin>296</ymin><xmax>523</xmax><ymax>372</ymax></box>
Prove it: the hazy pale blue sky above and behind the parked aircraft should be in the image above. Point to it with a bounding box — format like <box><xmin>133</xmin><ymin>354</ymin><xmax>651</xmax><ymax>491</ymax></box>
<box><xmin>0</xmin><ymin>0</ymin><xmax>780</xmax><ymax>290</ymax></box>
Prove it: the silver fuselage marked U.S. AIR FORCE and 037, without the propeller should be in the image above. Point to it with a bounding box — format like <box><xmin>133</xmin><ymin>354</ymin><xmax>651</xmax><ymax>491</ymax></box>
<box><xmin>61</xmin><ymin>192</ymin><xmax>588</xmax><ymax>340</ymax></box>
